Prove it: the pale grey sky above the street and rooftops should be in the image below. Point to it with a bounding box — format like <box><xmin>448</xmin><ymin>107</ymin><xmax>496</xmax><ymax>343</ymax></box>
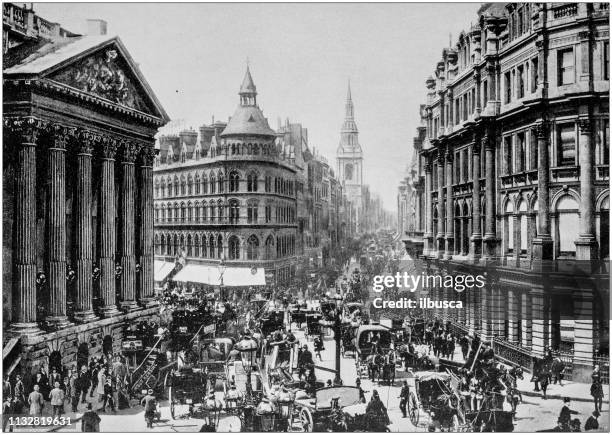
<box><xmin>34</xmin><ymin>3</ymin><xmax>479</xmax><ymax>211</ymax></box>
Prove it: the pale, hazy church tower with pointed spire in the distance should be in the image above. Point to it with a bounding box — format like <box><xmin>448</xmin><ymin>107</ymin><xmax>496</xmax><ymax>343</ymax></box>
<box><xmin>336</xmin><ymin>82</ymin><xmax>363</xmax><ymax>231</ymax></box>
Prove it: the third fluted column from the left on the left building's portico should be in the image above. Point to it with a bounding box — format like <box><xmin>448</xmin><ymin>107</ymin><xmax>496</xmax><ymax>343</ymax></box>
<box><xmin>74</xmin><ymin>131</ymin><xmax>100</xmax><ymax>323</ymax></box>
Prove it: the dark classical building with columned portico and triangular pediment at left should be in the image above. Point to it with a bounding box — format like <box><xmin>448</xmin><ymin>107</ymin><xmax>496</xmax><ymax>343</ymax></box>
<box><xmin>2</xmin><ymin>4</ymin><xmax>168</xmax><ymax>379</ymax></box>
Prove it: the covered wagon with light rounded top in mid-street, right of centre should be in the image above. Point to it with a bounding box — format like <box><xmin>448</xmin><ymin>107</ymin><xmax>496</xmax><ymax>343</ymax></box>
<box><xmin>355</xmin><ymin>325</ymin><xmax>395</xmax><ymax>382</ymax></box>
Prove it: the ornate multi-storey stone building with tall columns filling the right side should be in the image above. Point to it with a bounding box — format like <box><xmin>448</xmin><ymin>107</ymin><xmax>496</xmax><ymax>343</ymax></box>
<box><xmin>404</xmin><ymin>3</ymin><xmax>610</xmax><ymax>379</ymax></box>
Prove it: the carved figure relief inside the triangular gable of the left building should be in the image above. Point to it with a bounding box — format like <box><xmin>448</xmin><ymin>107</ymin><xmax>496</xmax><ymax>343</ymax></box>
<box><xmin>49</xmin><ymin>46</ymin><xmax>159</xmax><ymax>116</ymax></box>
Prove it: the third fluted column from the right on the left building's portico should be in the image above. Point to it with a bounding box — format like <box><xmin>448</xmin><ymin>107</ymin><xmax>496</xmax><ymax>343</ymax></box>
<box><xmin>100</xmin><ymin>138</ymin><xmax>120</xmax><ymax>317</ymax></box>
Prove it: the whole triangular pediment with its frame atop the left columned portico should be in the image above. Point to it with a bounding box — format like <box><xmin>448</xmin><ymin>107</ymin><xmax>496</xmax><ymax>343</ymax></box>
<box><xmin>41</xmin><ymin>40</ymin><xmax>165</xmax><ymax>118</ymax></box>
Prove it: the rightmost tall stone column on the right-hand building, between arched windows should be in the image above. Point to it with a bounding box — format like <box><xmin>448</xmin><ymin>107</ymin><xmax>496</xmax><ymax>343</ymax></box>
<box><xmin>576</xmin><ymin>119</ymin><xmax>598</xmax><ymax>261</ymax></box>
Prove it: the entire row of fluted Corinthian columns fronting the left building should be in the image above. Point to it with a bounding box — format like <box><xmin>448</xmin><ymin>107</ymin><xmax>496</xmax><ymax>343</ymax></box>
<box><xmin>5</xmin><ymin>117</ymin><xmax>154</xmax><ymax>333</ymax></box>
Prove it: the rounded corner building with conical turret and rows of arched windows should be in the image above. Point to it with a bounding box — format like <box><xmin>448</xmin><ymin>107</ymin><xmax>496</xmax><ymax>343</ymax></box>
<box><xmin>154</xmin><ymin>68</ymin><xmax>301</xmax><ymax>285</ymax></box>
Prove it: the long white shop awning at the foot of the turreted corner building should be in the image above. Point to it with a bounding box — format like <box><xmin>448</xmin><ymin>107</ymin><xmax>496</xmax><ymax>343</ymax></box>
<box><xmin>174</xmin><ymin>264</ymin><xmax>266</xmax><ymax>287</ymax></box>
